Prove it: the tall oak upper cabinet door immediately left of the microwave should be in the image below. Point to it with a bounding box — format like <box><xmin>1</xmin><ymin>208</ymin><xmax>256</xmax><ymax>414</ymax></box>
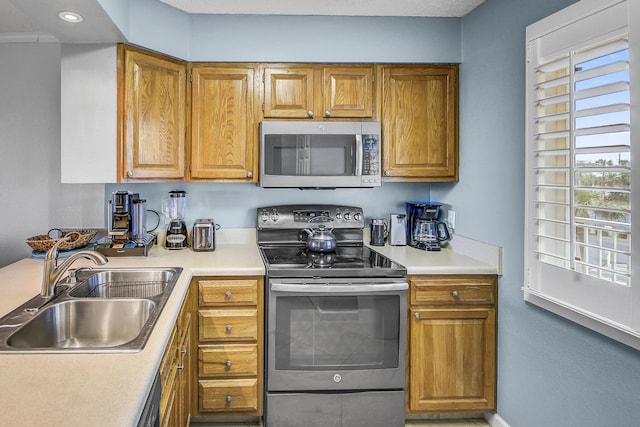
<box><xmin>190</xmin><ymin>64</ymin><xmax>258</xmax><ymax>182</ymax></box>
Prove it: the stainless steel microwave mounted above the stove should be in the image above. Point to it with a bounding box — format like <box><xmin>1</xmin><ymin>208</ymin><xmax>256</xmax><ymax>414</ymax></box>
<box><xmin>260</xmin><ymin>121</ymin><xmax>381</xmax><ymax>188</ymax></box>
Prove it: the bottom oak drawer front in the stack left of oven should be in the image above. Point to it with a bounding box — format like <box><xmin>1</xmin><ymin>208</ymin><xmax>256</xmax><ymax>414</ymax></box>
<box><xmin>198</xmin><ymin>378</ymin><xmax>261</xmax><ymax>412</ymax></box>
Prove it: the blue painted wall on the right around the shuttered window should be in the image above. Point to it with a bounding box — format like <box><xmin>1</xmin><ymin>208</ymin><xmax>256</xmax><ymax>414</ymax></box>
<box><xmin>431</xmin><ymin>0</ymin><xmax>640</xmax><ymax>427</ymax></box>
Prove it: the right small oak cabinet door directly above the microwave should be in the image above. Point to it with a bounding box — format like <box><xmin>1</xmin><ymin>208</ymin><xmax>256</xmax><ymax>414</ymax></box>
<box><xmin>323</xmin><ymin>66</ymin><xmax>374</xmax><ymax>118</ymax></box>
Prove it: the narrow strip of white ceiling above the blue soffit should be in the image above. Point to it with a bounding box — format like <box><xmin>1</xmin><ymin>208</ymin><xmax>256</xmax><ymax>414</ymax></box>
<box><xmin>160</xmin><ymin>0</ymin><xmax>485</xmax><ymax>17</ymax></box>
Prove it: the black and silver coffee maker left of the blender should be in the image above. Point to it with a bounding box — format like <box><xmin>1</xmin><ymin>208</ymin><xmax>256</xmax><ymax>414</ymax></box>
<box><xmin>96</xmin><ymin>191</ymin><xmax>155</xmax><ymax>256</ymax></box>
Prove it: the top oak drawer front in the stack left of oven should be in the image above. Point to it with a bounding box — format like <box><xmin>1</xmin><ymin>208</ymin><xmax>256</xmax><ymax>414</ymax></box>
<box><xmin>198</xmin><ymin>279</ymin><xmax>258</xmax><ymax>306</ymax></box>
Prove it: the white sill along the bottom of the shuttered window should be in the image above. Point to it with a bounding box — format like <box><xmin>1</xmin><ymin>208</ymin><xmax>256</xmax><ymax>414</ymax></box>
<box><xmin>522</xmin><ymin>288</ymin><xmax>640</xmax><ymax>350</ymax></box>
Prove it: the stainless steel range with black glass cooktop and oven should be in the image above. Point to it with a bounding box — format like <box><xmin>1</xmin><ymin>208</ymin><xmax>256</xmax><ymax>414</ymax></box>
<box><xmin>257</xmin><ymin>205</ymin><xmax>408</xmax><ymax>427</ymax></box>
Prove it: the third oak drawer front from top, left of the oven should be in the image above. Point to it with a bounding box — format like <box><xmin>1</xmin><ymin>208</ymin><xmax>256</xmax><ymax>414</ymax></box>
<box><xmin>198</xmin><ymin>344</ymin><xmax>258</xmax><ymax>378</ymax></box>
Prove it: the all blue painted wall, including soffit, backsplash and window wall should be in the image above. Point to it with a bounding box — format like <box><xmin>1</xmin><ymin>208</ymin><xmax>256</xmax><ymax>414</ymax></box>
<box><xmin>100</xmin><ymin>0</ymin><xmax>640</xmax><ymax>427</ymax></box>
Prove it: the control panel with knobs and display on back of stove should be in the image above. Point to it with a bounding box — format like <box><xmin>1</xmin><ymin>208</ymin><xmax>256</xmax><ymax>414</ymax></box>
<box><xmin>257</xmin><ymin>205</ymin><xmax>364</xmax><ymax>230</ymax></box>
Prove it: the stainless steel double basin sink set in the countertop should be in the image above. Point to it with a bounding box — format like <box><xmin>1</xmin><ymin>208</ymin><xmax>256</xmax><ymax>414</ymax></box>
<box><xmin>0</xmin><ymin>267</ymin><xmax>182</xmax><ymax>353</ymax></box>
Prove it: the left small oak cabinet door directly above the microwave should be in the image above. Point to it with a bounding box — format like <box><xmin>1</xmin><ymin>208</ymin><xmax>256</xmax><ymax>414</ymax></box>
<box><xmin>263</xmin><ymin>67</ymin><xmax>316</xmax><ymax>119</ymax></box>
